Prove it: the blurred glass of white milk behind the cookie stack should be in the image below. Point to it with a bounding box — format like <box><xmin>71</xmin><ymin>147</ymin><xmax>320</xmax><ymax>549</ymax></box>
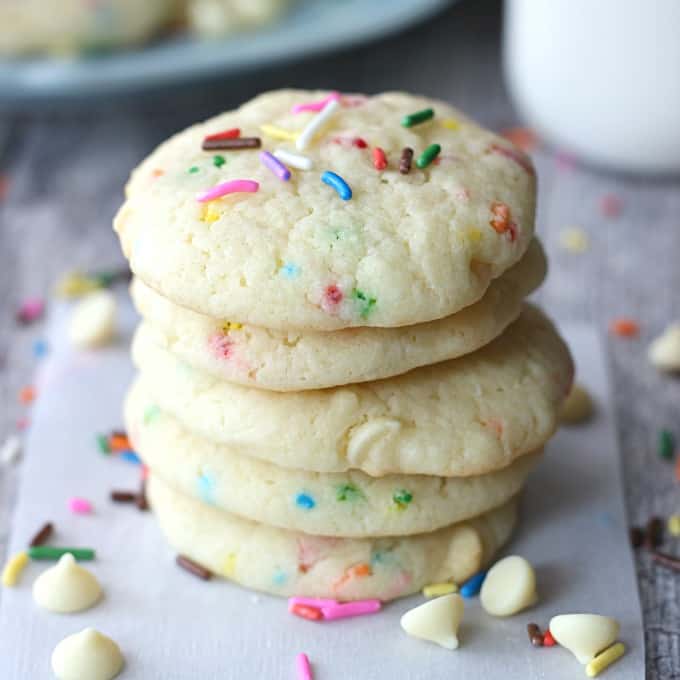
<box><xmin>503</xmin><ymin>0</ymin><xmax>680</xmax><ymax>173</ymax></box>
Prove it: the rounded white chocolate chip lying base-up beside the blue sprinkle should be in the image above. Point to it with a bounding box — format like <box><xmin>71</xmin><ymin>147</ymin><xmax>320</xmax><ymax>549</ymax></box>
<box><xmin>479</xmin><ymin>555</ymin><xmax>536</xmax><ymax>616</ymax></box>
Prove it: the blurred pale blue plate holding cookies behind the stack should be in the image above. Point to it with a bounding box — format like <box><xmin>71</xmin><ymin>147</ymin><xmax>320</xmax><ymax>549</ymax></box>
<box><xmin>0</xmin><ymin>0</ymin><xmax>451</xmax><ymax>102</ymax></box>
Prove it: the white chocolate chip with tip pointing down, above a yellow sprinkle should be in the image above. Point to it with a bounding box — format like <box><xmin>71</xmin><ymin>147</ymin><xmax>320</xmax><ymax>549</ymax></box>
<box><xmin>550</xmin><ymin>614</ymin><xmax>619</xmax><ymax>664</ymax></box>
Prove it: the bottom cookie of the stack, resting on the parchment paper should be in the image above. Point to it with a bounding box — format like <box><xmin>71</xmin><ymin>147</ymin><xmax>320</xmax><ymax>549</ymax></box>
<box><xmin>147</xmin><ymin>475</ymin><xmax>517</xmax><ymax>601</ymax></box>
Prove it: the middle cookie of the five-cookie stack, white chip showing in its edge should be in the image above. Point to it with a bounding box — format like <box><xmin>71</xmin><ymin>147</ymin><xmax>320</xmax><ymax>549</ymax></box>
<box><xmin>132</xmin><ymin>305</ymin><xmax>572</xmax><ymax>476</ymax></box>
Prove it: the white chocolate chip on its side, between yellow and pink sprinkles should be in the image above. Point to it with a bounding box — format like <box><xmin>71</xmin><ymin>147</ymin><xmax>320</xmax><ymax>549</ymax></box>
<box><xmin>401</xmin><ymin>593</ymin><xmax>465</xmax><ymax>649</ymax></box>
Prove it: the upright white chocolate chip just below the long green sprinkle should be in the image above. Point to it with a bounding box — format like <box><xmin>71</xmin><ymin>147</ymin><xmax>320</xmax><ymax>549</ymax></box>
<box><xmin>33</xmin><ymin>553</ymin><xmax>102</xmax><ymax>614</ymax></box>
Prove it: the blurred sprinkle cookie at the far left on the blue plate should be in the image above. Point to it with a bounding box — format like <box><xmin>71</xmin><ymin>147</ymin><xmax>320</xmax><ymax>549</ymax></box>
<box><xmin>0</xmin><ymin>0</ymin><xmax>177</xmax><ymax>56</ymax></box>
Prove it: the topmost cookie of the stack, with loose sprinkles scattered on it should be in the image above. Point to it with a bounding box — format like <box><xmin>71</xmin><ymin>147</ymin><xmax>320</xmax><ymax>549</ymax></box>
<box><xmin>114</xmin><ymin>90</ymin><xmax>535</xmax><ymax>330</ymax></box>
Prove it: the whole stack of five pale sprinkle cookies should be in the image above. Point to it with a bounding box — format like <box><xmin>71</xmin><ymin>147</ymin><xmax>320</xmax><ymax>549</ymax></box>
<box><xmin>115</xmin><ymin>91</ymin><xmax>572</xmax><ymax>600</ymax></box>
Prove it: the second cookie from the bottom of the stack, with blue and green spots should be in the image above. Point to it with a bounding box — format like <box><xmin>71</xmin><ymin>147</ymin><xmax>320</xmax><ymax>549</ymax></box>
<box><xmin>125</xmin><ymin>384</ymin><xmax>540</xmax><ymax>537</ymax></box>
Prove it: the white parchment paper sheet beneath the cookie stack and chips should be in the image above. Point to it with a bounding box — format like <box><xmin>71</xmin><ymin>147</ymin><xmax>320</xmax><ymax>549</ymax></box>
<box><xmin>0</xmin><ymin>305</ymin><xmax>644</xmax><ymax>680</ymax></box>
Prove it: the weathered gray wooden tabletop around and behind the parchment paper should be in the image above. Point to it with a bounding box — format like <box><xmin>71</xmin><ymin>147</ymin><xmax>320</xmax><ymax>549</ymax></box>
<box><xmin>0</xmin><ymin>0</ymin><xmax>680</xmax><ymax>680</ymax></box>
